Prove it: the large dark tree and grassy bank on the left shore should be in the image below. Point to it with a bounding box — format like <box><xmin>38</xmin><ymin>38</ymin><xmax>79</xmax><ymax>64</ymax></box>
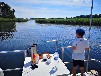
<box><xmin>0</xmin><ymin>2</ymin><xmax>28</xmax><ymax>22</ymax></box>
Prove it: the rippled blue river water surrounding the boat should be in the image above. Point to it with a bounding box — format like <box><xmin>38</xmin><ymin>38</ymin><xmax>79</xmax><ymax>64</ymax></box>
<box><xmin>0</xmin><ymin>20</ymin><xmax>101</xmax><ymax>72</ymax></box>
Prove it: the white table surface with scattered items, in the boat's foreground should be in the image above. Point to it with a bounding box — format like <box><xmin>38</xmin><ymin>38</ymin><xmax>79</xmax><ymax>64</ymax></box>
<box><xmin>22</xmin><ymin>54</ymin><xmax>70</xmax><ymax>76</ymax></box>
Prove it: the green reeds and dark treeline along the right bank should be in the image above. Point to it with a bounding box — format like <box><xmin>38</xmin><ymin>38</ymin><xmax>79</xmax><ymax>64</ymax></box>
<box><xmin>34</xmin><ymin>14</ymin><xmax>101</xmax><ymax>26</ymax></box>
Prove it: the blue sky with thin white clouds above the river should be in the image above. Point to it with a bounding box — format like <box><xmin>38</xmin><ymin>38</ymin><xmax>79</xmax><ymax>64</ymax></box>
<box><xmin>0</xmin><ymin>0</ymin><xmax>101</xmax><ymax>18</ymax></box>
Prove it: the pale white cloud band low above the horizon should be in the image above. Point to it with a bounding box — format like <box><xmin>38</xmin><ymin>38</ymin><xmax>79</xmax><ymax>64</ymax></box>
<box><xmin>13</xmin><ymin>6</ymin><xmax>87</xmax><ymax>18</ymax></box>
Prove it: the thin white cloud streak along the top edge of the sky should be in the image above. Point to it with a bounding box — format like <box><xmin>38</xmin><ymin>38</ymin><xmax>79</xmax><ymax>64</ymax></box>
<box><xmin>4</xmin><ymin>0</ymin><xmax>91</xmax><ymax>7</ymax></box>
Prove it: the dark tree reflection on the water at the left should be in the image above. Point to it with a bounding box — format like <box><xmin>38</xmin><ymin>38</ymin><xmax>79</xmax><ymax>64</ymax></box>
<box><xmin>0</xmin><ymin>22</ymin><xmax>16</xmax><ymax>41</ymax></box>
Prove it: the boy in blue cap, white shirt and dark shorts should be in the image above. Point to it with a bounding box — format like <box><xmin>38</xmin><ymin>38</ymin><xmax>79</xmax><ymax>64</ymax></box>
<box><xmin>72</xmin><ymin>29</ymin><xmax>89</xmax><ymax>76</ymax></box>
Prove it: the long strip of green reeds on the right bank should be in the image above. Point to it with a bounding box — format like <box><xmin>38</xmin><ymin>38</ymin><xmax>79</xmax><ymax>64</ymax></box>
<box><xmin>35</xmin><ymin>18</ymin><xmax>101</xmax><ymax>26</ymax></box>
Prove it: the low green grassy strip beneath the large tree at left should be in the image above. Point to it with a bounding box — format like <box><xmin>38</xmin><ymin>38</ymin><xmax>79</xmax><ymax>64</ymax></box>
<box><xmin>0</xmin><ymin>18</ymin><xmax>28</xmax><ymax>22</ymax></box>
